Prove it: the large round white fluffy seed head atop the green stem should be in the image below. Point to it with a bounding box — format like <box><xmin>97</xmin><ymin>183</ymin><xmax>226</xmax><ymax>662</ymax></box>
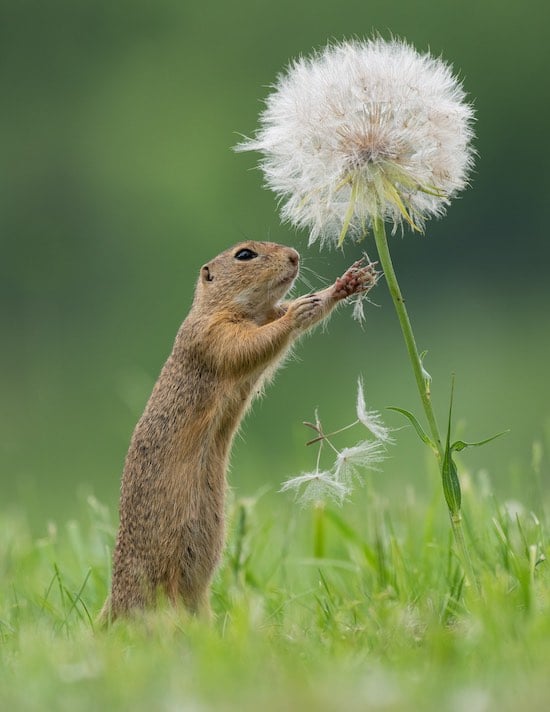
<box><xmin>237</xmin><ymin>39</ymin><xmax>474</xmax><ymax>250</ymax></box>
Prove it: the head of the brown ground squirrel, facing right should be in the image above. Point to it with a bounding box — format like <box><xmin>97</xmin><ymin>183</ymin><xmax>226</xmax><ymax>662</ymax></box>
<box><xmin>195</xmin><ymin>240</ymin><xmax>300</xmax><ymax>318</ymax></box>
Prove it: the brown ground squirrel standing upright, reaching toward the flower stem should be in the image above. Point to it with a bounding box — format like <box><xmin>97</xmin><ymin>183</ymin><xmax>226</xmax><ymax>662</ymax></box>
<box><xmin>101</xmin><ymin>241</ymin><xmax>377</xmax><ymax>621</ymax></box>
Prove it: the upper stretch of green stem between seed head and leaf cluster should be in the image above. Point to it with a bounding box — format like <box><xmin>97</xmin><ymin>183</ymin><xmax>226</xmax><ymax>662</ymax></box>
<box><xmin>373</xmin><ymin>219</ymin><xmax>444</xmax><ymax>461</ymax></box>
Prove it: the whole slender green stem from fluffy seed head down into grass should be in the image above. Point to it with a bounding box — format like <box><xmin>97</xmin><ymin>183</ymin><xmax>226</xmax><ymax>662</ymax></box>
<box><xmin>373</xmin><ymin>218</ymin><xmax>479</xmax><ymax>590</ymax></box>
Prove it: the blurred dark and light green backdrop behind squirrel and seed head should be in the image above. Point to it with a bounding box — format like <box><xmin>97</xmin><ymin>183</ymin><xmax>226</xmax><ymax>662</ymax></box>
<box><xmin>0</xmin><ymin>0</ymin><xmax>550</xmax><ymax>527</ymax></box>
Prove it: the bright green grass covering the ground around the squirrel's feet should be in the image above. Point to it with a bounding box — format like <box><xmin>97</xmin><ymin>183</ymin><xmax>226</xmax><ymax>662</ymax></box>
<box><xmin>0</xmin><ymin>478</ymin><xmax>550</xmax><ymax>712</ymax></box>
